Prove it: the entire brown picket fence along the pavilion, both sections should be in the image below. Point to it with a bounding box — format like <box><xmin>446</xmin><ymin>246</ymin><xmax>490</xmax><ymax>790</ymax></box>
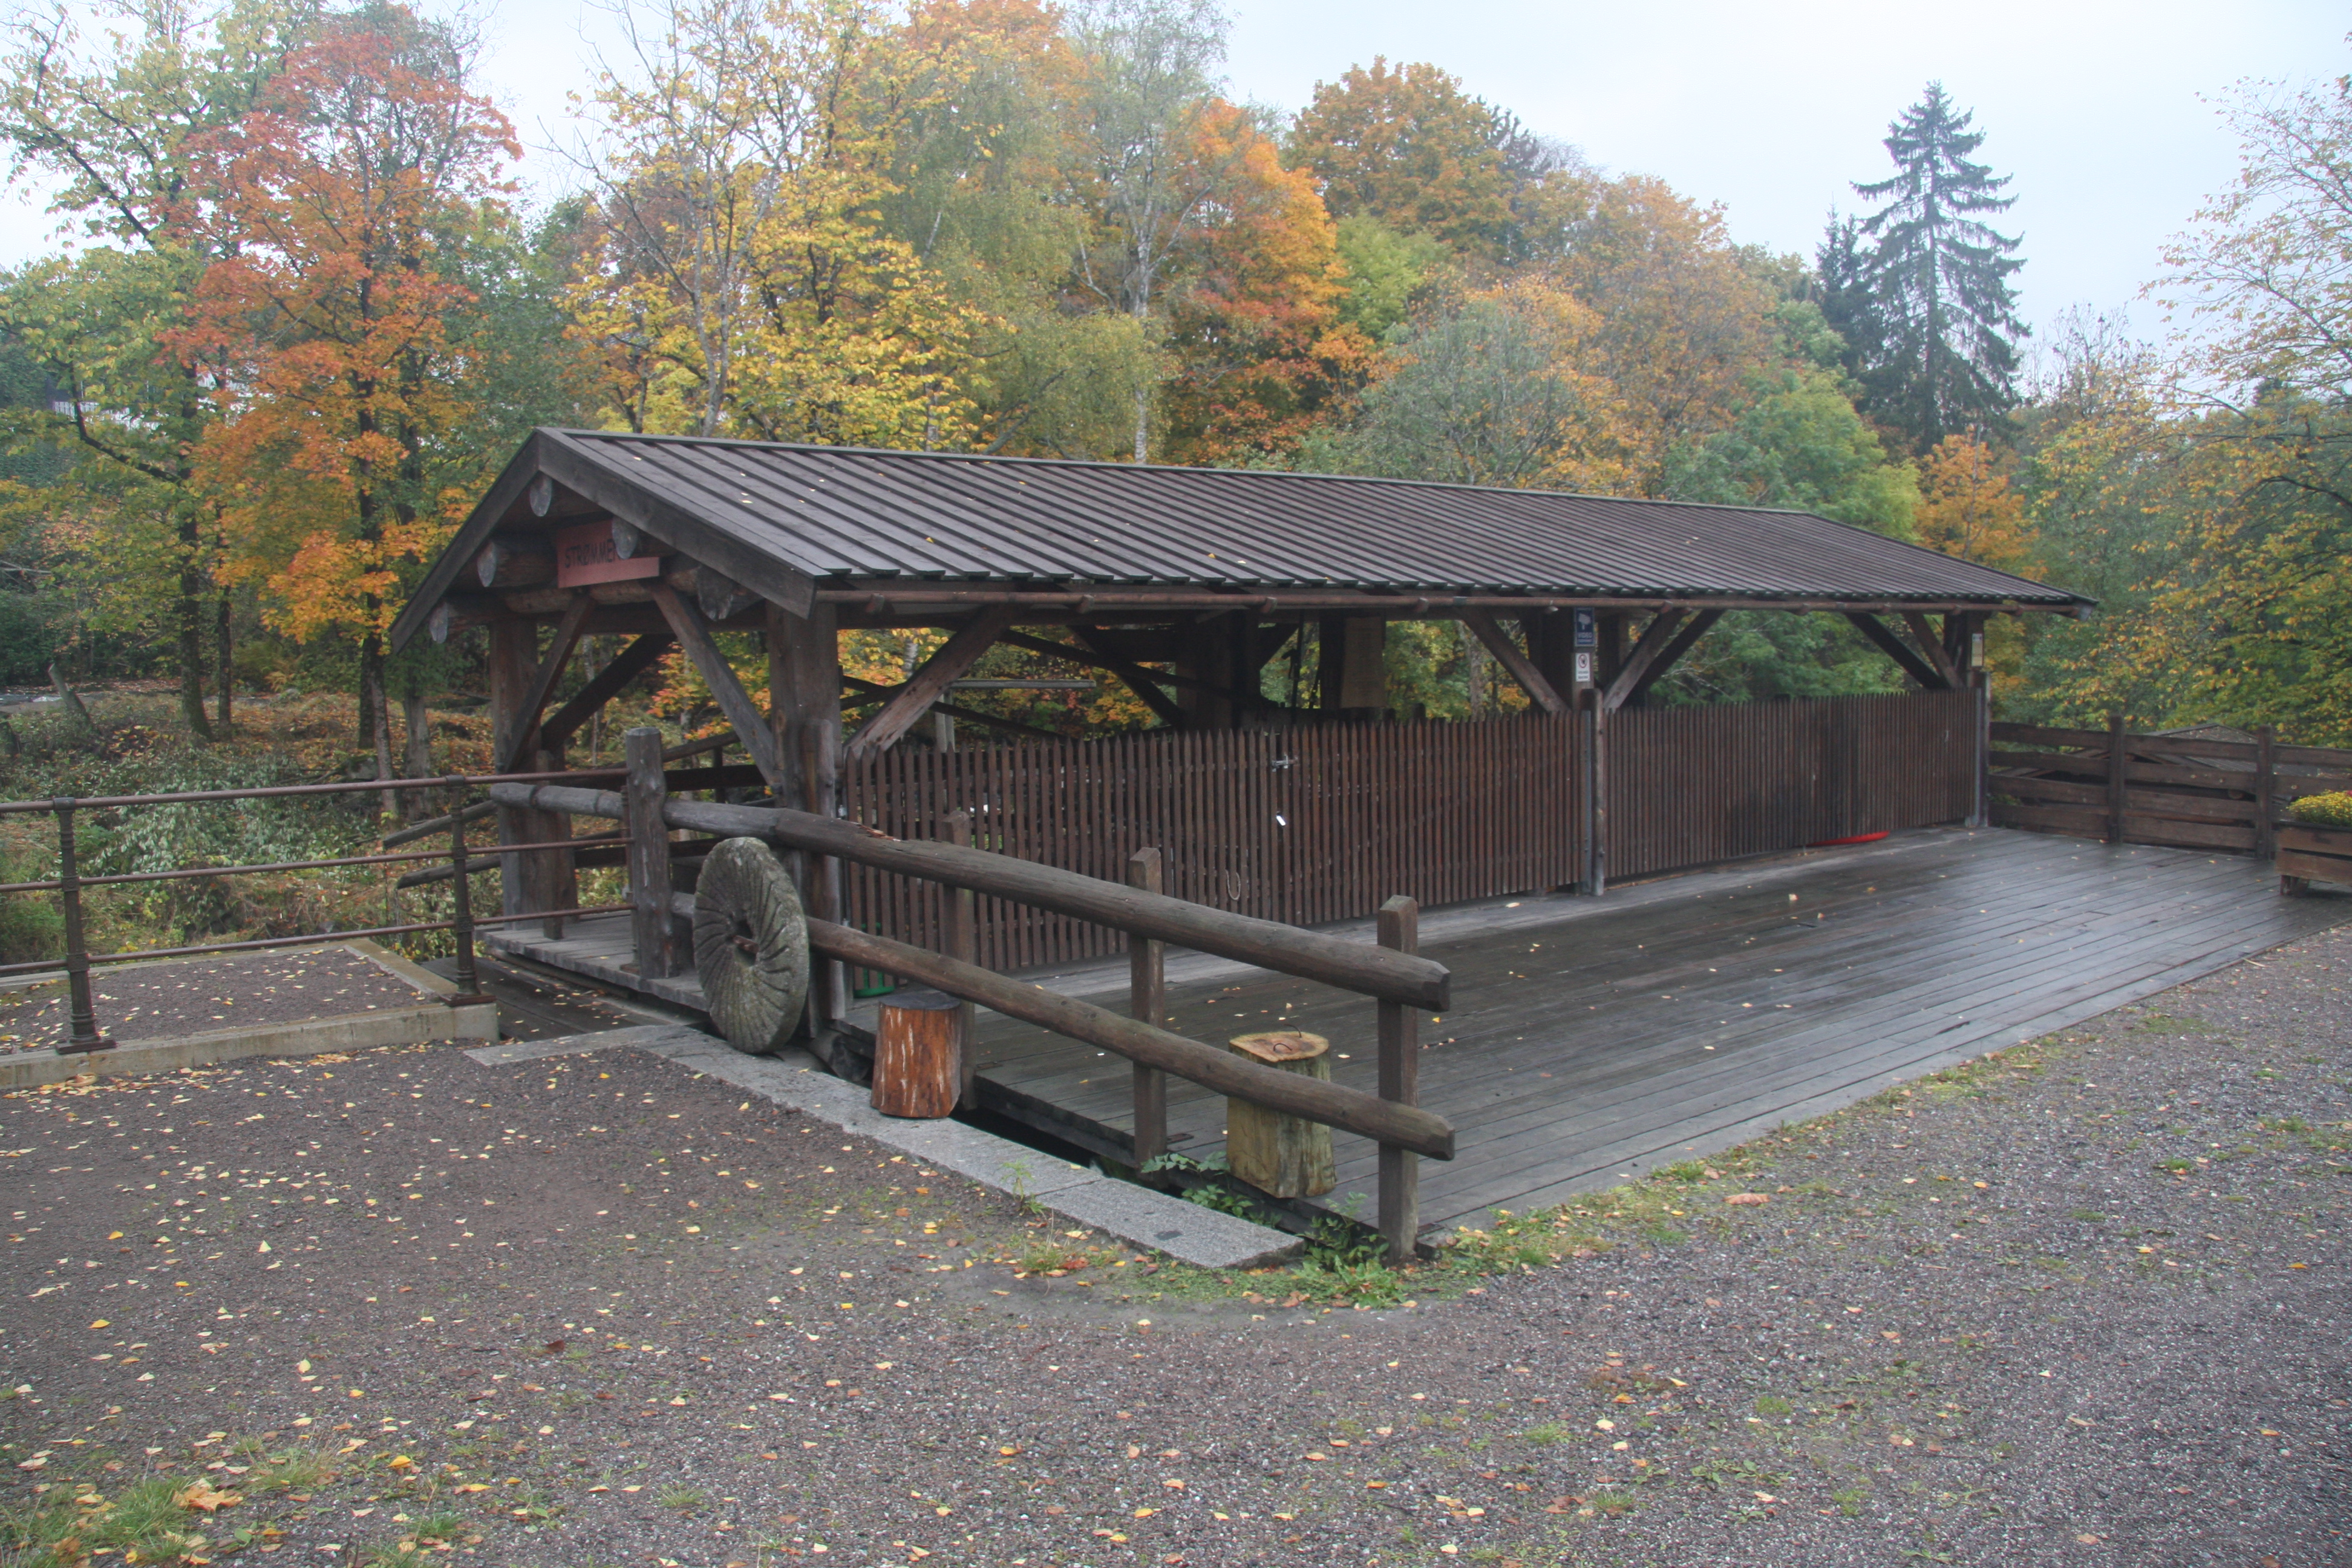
<box><xmin>842</xmin><ymin>691</ymin><xmax>1981</xmax><ymax>969</ymax></box>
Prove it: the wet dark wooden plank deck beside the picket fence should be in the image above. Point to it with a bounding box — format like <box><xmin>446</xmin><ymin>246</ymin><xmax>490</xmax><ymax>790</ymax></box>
<box><xmin>494</xmin><ymin>830</ymin><xmax>2352</xmax><ymax>1225</ymax></box>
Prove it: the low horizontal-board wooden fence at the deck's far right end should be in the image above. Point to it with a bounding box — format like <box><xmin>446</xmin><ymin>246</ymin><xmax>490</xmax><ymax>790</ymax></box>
<box><xmin>1987</xmin><ymin>722</ymin><xmax>2352</xmax><ymax>858</ymax></box>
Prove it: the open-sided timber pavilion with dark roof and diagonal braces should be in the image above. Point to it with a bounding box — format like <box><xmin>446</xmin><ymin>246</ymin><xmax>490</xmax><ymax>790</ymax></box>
<box><xmin>393</xmin><ymin>430</ymin><xmax>2089</xmax><ymax>1048</ymax></box>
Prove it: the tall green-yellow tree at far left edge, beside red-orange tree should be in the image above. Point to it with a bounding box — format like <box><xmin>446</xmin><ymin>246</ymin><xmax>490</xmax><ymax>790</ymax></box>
<box><xmin>0</xmin><ymin>0</ymin><xmax>318</xmax><ymax>736</ymax></box>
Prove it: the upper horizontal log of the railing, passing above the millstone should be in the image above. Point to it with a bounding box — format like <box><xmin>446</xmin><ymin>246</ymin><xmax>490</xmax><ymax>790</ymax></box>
<box><xmin>489</xmin><ymin>783</ymin><xmax>1454</xmax><ymax>1013</ymax></box>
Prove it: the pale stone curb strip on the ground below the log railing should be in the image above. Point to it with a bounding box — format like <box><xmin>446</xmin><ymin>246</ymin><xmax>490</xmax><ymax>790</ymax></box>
<box><xmin>466</xmin><ymin>1025</ymin><xmax>1303</xmax><ymax>1269</ymax></box>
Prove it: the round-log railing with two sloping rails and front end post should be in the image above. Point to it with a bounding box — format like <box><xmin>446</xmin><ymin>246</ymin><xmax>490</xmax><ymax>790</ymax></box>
<box><xmin>492</xmin><ymin>774</ymin><xmax>1454</xmax><ymax>1260</ymax></box>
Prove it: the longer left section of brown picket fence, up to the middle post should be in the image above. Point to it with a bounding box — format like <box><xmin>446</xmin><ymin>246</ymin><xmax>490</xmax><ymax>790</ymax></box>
<box><xmin>842</xmin><ymin>714</ymin><xmax>1583</xmax><ymax>969</ymax></box>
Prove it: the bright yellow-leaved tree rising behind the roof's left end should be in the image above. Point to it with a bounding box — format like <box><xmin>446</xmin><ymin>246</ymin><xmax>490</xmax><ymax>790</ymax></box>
<box><xmin>574</xmin><ymin>0</ymin><xmax>981</xmax><ymax>446</ymax></box>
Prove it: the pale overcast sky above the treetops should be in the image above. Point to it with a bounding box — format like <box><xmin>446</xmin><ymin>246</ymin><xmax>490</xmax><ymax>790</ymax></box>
<box><xmin>0</xmin><ymin>0</ymin><xmax>2352</xmax><ymax>343</ymax></box>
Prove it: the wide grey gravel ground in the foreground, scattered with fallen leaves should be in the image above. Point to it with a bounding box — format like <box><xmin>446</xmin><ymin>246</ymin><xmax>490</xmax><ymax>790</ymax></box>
<box><xmin>0</xmin><ymin>931</ymin><xmax>2352</xmax><ymax>1568</ymax></box>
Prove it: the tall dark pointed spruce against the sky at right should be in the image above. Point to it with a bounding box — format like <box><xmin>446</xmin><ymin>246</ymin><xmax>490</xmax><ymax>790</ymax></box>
<box><xmin>1823</xmin><ymin>82</ymin><xmax>2027</xmax><ymax>451</ymax></box>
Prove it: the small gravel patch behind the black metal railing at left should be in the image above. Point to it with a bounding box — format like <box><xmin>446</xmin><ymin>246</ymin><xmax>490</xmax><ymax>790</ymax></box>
<box><xmin>0</xmin><ymin>947</ymin><xmax>428</xmax><ymax>1053</ymax></box>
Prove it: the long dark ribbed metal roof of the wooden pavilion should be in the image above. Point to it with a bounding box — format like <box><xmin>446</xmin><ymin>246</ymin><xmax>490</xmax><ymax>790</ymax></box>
<box><xmin>395</xmin><ymin>430</ymin><xmax>2089</xmax><ymax>639</ymax></box>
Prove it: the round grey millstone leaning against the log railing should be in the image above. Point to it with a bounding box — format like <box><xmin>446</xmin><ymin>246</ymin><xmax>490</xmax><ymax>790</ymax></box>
<box><xmin>694</xmin><ymin>839</ymin><xmax>809</xmax><ymax>1056</ymax></box>
